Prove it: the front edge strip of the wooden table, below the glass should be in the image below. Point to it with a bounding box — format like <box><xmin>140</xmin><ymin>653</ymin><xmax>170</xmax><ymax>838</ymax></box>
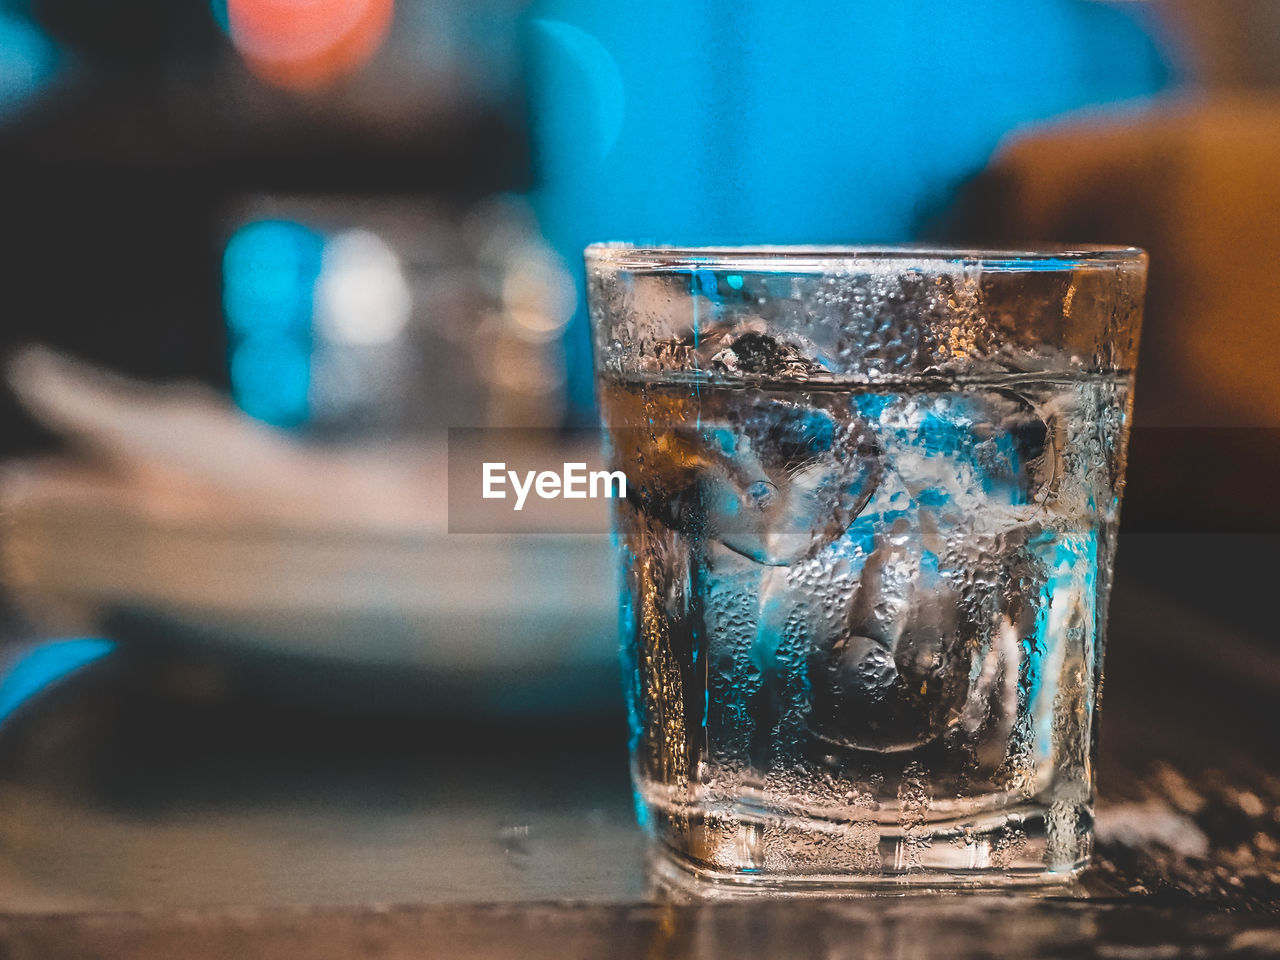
<box><xmin>0</xmin><ymin>897</ymin><xmax>1280</xmax><ymax>960</ymax></box>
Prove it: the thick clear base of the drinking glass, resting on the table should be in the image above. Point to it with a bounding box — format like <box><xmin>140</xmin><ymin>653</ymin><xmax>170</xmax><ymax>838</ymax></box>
<box><xmin>648</xmin><ymin>803</ymin><xmax>1093</xmax><ymax>895</ymax></box>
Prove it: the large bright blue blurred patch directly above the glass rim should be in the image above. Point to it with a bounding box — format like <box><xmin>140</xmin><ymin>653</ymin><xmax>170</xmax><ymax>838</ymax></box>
<box><xmin>527</xmin><ymin>0</ymin><xmax>1172</xmax><ymax>416</ymax></box>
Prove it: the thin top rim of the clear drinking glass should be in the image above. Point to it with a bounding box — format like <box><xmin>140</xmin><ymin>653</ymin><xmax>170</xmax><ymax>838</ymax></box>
<box><xmin>582</xmin><ymin>242</ymin><xmax>1148</xmax><ymax>273</ymax></box>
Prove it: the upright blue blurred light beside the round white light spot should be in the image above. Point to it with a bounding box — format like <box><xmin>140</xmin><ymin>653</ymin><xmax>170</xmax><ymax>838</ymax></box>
<box><xmin>223</xmin><ymin>220</ymin><xmax>324</xmax><ymax>426</ymax></box>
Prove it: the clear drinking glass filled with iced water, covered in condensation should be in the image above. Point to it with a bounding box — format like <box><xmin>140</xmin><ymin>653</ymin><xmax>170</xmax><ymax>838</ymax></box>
<box><xmin>586</xmin><ymin>244</ymin><xmax>1147</xmax><ymax>890</ymax></box>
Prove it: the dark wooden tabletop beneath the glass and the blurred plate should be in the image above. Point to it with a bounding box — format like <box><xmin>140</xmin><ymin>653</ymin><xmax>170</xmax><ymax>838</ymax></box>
<box><xmin>0</xmin><ymin>535</ymin><xmax>1280</xmax><ymax>959</ymax></box>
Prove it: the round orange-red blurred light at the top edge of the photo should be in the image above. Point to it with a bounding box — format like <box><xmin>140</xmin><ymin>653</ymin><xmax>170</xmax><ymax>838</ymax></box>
<box><xmin>227</xmin><ymin>0</ymin><xmax>396</xmax><ymax>90</ymax></box>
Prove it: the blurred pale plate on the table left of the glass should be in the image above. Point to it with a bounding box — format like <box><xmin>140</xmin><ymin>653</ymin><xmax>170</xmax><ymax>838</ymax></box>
<box><xmin>3</xmin><ymin>465</ymin><xmax>617</xmax><ymax>680</ymax></box>
